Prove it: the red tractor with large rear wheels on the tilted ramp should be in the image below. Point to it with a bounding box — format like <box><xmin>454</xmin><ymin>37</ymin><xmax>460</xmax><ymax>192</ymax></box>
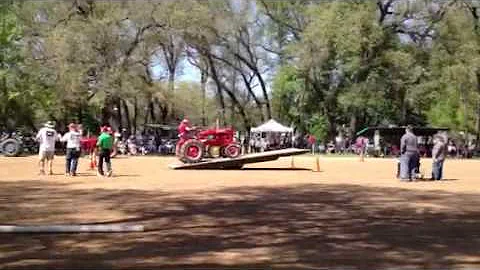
<box><xmin>176</xmin><ymin>128</ymin><xmax>241</xmax><ymax>163</ymax></box>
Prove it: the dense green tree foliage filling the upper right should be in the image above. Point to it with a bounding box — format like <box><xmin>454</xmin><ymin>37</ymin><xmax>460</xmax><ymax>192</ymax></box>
<box><xmin>273</xmin><ymin>1</ymin><xmax>480</xmax><ymax>138</ymax></box>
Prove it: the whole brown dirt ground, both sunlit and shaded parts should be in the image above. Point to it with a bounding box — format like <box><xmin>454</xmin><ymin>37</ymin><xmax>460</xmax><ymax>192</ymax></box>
<box><xmin>0</xmin><ymin>156</ymin><xmax>480</xmax><ymax>269</ymax></box>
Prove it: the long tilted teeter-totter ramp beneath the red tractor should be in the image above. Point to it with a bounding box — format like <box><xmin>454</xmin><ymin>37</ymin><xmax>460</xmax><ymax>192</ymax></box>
<box><xmin>169</xmin><ymin>148</ymin><xmax>310</xmax><ymax>170</ymax></box>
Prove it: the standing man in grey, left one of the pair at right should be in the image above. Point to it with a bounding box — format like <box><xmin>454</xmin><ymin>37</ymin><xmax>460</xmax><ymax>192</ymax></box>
<box><xmin>400</xmin><ymin>125</ymin><xmax>420</xmax><ymax>181</ymax></box>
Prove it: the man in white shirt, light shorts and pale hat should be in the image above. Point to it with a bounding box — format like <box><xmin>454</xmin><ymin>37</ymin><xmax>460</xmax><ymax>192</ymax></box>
<box><xmin>36</xmin><ymin>121</ymin><xmax>58</xmax><ymax>175</ymax></box>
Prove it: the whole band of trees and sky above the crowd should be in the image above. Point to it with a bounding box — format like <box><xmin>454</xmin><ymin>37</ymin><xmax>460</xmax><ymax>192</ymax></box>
<box><xmin>0</xmin><ymin>0</ymin><xmax>480</xmax><ymax>143</ymax></box>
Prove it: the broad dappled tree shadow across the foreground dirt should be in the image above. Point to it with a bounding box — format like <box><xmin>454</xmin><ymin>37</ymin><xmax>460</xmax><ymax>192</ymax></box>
<box><xmin>0</xmin><ymin>181</ymin><xmax>480</xmax><ymax>269</ymax></box>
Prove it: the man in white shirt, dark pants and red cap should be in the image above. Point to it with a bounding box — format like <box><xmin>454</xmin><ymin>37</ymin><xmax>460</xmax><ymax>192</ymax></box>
<box><xmin>61</xmin><ymin>123</ymin><xmax>81</xmax><ymax>176</ymax></box>
